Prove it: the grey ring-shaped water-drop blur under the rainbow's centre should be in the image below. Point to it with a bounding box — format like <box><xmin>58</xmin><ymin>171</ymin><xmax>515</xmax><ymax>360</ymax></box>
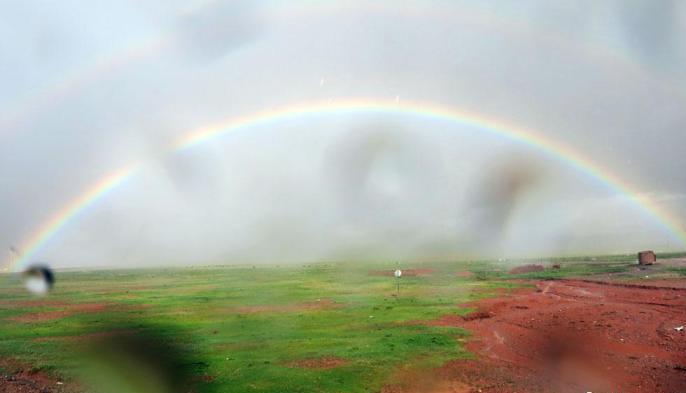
<box><xmin>327</xmin><ymin>124</ymin><xmax>439</xmax><ymax>217</ymax></box>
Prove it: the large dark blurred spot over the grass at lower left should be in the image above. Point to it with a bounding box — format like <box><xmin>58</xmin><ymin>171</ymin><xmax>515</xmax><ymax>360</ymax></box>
<box><xmin>81</xmin><ymin>326</ymin><xmax>206</xmax><ymax>393</ymax></box>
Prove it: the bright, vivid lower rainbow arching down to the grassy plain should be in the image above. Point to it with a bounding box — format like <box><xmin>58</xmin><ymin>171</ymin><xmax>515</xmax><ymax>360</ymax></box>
<box><xmin>10</xmin><ymin>99</ymin><xmax>686</xmax><ymax>271</ymax></box>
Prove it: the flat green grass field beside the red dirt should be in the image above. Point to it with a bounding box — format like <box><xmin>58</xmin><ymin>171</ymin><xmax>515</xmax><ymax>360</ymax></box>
<box><xmin>0</xmin><ymin>257</ymin><xmax>672</xmax><ymax>392</ymax></box>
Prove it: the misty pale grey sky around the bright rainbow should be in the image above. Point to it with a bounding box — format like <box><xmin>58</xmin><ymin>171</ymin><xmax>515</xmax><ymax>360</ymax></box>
<box><xmin>0</xmin><ymin>0</ymin><xmax>686</xmax><ymax>267</ymax></box>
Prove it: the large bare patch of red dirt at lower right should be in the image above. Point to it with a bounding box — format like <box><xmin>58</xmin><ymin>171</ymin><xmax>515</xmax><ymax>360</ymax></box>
<box><xmin>398</xmin><ymin>280</ymin><xmax>686</xmax><ymax>392</ymax></box>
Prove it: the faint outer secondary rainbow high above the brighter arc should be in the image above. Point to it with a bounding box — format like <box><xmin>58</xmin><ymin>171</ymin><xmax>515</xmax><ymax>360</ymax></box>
<box><xmin>0</xmin><ymin>1</ymin><xmax>684</xmax><ymax>136</ymax></box>
